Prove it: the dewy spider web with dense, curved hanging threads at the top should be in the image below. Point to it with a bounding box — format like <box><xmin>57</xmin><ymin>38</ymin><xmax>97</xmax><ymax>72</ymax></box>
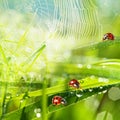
<box><xmin>25</xmin><ymin>0</ymin><xmax>101</xmax><ymax>43</ymax></box>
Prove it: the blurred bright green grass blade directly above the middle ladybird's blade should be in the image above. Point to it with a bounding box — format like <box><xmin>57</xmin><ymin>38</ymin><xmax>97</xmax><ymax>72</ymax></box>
<box><xmin>48</xmin><ymin>59</ymin><xmax>120</xmax><ymax>79</ymax></box>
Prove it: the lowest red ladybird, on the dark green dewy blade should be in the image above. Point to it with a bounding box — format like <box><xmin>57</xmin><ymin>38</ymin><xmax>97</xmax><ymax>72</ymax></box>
<box><xmin>52</xmin><ymin>96</ymin><xmax>67</xmax><ymax>105</ymax></box>
